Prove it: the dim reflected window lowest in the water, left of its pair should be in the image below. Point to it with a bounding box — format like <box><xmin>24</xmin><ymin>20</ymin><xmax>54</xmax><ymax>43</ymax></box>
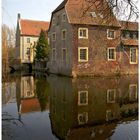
<box><xmin>78</xmin><ymin>112</ymin><xmax>88</xmax><ymax>125</ymax></box>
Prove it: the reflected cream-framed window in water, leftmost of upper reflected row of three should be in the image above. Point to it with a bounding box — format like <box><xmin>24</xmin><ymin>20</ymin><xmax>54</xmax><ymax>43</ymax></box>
<box><xmin>78</xmin><ymin>91</ymin><xmax>88</xmax><ymax>105</ymax></box>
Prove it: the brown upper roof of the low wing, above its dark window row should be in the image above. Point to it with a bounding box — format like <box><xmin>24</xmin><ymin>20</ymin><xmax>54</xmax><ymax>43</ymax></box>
<box><xmin>120</xmin><ymin>21</ymin><xmax>139</xmax><ymax>31</ymax></box>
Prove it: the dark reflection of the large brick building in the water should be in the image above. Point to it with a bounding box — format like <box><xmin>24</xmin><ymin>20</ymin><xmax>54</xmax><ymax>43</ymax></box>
<box><xmin>49</xmin><ymin>76</ymin><xmax>138</xmax><ymax>140</ymax></box>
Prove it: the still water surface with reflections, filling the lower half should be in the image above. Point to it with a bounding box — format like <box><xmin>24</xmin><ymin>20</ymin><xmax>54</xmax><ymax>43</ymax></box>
<box><xmin>2</xmin><ymin>74</ymin><xmax>138</xmax><ymax>140</ymax></box>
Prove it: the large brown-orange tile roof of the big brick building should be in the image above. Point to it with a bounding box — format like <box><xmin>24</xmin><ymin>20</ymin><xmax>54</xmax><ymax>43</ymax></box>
<box><xmin>53</xmin><ymin>0</ymin><xmax>120</xmax><ymax>27</ymax></box>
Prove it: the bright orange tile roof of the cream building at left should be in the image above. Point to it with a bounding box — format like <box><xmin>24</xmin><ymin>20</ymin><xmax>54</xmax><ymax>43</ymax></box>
<box><xmin>19</xmin><ymin>19</ymin><xmax>49</xmax><ymax>36</ymax></box>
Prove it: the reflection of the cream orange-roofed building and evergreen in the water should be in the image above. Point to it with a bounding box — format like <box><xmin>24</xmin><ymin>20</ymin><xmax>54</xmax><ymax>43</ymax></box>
<box><xmin>16</xmin><ymin>76</ymin><xmax>49</xmax><ymax>117</ymax></box>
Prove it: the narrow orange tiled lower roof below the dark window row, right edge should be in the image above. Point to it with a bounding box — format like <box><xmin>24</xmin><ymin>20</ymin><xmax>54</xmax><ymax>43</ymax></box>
<box><xmin>122</xmin><ymin>39</ymin><xmax>139</xmax><ymax>46</ymax></box>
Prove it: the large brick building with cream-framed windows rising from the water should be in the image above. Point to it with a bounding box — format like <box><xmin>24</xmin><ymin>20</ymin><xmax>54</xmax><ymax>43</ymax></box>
<box><xmin>49</xmin><ymin>0</ymin><xmax>138</xmax><ymax>77</ymax></box>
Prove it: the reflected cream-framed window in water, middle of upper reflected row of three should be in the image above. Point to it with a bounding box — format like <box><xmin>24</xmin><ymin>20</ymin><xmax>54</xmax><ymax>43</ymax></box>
<box><xmin>107</xmin><ymin>89</ymin><xmax>116</xmax><ymax>103</ymax></box>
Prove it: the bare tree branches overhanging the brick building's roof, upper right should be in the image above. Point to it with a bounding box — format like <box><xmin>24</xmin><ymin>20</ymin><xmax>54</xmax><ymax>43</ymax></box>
<box><xmin>83</xmin><ymin>0</ymin><xmax>139</xmax><ymax>21</ymax></box>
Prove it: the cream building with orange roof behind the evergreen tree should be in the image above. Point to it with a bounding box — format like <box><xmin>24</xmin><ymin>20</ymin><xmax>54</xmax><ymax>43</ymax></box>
<box><xmin>16</xmin><ymin>14</ymin><xmax>49</xmax><ymax>63</ymax></box>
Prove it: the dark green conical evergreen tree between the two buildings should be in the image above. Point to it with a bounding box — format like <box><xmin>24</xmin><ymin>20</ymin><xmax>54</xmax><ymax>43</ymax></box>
<box><xmin>35</xmin><ymin>30</ymin><xmax>50</xmax><ymax>61</ymax></box>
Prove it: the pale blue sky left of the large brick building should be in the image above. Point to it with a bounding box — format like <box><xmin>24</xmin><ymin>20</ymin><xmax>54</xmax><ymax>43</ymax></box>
<box><xmin>2</xmin><ymin>0</ymin><xmax>63</xmax><ymax>27</ymax></box>
